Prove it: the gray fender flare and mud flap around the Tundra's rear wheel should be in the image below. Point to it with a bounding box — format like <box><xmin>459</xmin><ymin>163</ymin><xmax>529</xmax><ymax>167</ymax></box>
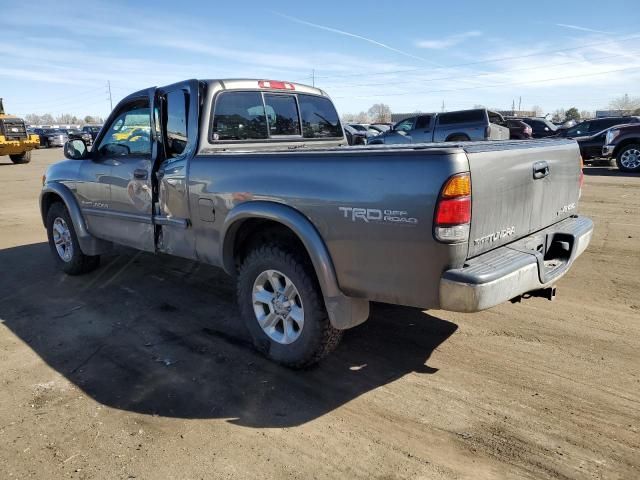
<box><xmin>220</xmin><ymin>201</ymin><xmax>369</xmax><ymax>329</ymax></box>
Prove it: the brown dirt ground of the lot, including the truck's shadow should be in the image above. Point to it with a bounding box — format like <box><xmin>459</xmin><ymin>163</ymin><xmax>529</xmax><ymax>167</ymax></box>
<box><xmin>0</xmin><ymin>149</ymin><xmax>640</xmax><ymax>480</ymax></box>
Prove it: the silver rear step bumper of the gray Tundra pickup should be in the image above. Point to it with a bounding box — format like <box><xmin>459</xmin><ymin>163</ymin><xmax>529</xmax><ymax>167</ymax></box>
<box><xmin>440</xmin><ymin>216</ymin><xmax>593</xmax><ymax>312</ymax></box>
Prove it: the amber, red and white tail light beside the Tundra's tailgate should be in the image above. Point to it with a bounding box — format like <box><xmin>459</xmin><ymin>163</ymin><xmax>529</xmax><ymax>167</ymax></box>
<box><xmin>433</xmin><ymin>172</ymin><xmax>471</xmax><ymax>243</ymax></box>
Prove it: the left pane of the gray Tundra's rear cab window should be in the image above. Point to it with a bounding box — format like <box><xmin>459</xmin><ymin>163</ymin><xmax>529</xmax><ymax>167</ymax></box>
<box><xmin>212</xmin><ymin>92</ymin><xmax>268</xmax><ymax>140</ymax></box>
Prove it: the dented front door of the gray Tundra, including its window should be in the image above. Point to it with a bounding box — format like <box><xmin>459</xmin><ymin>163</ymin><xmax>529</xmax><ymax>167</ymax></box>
<box><xmin>94</xmin><ymin>90</ymin><xmax>157</xmax><ymax>252</ymax></box>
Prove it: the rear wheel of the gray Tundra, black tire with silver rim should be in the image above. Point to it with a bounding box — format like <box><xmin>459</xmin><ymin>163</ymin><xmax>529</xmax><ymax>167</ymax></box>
<box><xmin>237</xmin><ymin>244</ymin><xmax>342</xmax><ymax>369</ymax></box>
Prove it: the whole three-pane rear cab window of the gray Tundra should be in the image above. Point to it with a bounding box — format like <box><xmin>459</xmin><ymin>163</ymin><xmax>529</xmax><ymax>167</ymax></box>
<box><xmin>210</xmin><ymin>91</ymin><xmax>343</xmax><ymax>142</ymax></box>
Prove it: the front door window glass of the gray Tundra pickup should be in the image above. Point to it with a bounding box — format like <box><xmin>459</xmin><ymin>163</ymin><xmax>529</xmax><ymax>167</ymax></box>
<box><xmin>98</xmin><ymin>100</ymin><xmax>151</xmax><ymax>156</ymax></box>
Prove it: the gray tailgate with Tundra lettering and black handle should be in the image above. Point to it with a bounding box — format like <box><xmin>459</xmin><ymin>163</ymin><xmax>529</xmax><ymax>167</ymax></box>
<box><xmin>465</xmin><ymin>139</ymin><xmax>580</xmax><ymax>258</ymax></box>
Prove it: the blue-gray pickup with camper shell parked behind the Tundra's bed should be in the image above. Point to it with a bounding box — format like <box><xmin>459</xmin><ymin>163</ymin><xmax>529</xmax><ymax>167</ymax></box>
<box><xmin>369</xmin><ymin>108</ymin><xmax>509</xmax><ymax>145</ymax></box>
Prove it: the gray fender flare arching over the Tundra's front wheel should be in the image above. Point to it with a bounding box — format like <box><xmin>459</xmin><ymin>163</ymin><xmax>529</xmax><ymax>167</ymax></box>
<box><xmin>39</xmin><ymin>182</ymin><xmax>111</xmax><ymax>255</ymax></box>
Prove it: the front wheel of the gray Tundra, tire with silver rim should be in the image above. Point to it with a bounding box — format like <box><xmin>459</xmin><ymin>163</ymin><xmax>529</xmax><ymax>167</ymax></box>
<box><xmin>47</xmin><ymin>202</ymin><xmax>100</xmax><ymax>275</ymax></box>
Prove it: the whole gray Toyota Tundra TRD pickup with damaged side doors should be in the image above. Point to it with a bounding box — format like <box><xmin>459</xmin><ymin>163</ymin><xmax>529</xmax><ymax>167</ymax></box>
<box><xmin>40</xmin><ymin>80</ymin><xmax>593</xmax><ymax>367</ymax></box>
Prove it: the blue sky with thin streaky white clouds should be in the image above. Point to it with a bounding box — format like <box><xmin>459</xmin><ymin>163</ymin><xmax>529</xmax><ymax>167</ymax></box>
<box><xmin>0</xmin><ymin>0</ymin><xmax>640</xmax><ymax>117</ymax></box>
